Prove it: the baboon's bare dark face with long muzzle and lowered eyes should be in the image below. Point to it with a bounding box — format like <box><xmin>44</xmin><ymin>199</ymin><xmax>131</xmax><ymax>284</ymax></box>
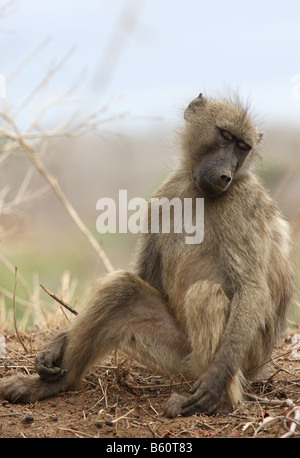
<box><xmin>192</xmin><ymin>127</ymin><xmax>251</xmax><ymax>197</ymax></box>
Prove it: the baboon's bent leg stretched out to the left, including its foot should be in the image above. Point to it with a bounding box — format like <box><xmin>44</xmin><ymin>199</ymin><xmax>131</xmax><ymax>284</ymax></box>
<box><xmin>0</xmin><ymin>272</ymin><xmax>190</xmax><ymax>402</ymax></box>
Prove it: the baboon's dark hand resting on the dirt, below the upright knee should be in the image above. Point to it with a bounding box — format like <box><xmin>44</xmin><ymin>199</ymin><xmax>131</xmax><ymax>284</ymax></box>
<box><xmin>181</xmin><ymin>376</ymin><xmax>223</xmax><ymax>417</ymax></box>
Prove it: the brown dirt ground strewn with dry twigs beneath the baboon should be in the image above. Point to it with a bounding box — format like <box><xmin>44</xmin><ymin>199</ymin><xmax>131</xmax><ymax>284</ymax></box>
<box><xmin>0</xmin><ymin>331</ymin><xmax>300</xmax><ymax>440</ymax></box>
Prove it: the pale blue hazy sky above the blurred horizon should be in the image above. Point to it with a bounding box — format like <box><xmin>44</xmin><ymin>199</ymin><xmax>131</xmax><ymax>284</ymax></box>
<box><xmin>0</xmin><ymin>0</ymin><xmax>300</xmax><ymax>129</ymax></box>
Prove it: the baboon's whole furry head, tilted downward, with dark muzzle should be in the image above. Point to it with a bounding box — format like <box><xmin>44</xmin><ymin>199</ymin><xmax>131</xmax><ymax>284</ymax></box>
<box><xmin>183</xmin><ymin>94</ymin><xmax>262</xmax><ymax>197</ymax></box>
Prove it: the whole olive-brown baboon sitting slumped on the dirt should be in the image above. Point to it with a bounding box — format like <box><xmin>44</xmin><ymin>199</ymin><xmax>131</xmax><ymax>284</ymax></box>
<box><xmin>0</xmin><ymin>94</ymin><xmax>293</xmax><ymax>417</ymax></box>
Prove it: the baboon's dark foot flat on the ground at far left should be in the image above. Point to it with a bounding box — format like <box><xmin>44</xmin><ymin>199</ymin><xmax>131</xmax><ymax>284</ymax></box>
<box><xmin>0</xmin><ymin>375</ymin><xmax>64</xmax><ymax>404</ymax></box>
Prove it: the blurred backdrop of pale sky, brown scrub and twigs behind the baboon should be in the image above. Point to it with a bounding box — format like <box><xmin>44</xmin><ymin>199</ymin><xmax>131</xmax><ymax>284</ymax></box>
<box><xmin>0</xmin><ymin>0</ymin><xmax>300</xmax><ymax>333</ymax></box>
